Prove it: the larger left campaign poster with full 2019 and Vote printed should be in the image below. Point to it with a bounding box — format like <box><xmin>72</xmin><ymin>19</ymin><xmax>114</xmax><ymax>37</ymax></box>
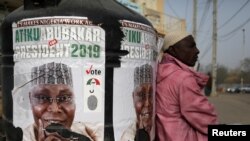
<box><xmin>12</xmin><ymin>16</ymin><xmax>105</xmax><ymax>141</ymax></box>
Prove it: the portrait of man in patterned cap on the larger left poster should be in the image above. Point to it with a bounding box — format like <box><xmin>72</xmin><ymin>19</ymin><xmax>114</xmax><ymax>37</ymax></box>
<box><xmin>23</xmin><ymin>62</ymin><xmax>103</xmax><ymax>141</ymax></box>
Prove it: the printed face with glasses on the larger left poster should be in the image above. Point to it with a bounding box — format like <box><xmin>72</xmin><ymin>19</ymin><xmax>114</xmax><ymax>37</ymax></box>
<box><xmin>29</xmin><ymin>84</ymin><xmax>75</xmax><ymax>129</ymax></box>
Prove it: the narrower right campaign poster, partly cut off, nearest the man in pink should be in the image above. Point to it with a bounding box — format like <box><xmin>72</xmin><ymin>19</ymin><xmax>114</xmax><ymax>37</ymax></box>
<box><xmin>113</xmin><ymin>20</ymin><xmax>158</xmax><ymax>141</ymax></box>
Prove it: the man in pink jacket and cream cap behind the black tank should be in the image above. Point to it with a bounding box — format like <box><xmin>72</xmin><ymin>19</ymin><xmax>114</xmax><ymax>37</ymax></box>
<box><xmin>156</xmin><ymin>31</ymin><xmax>217</xmax><ymax>141</ymax></box>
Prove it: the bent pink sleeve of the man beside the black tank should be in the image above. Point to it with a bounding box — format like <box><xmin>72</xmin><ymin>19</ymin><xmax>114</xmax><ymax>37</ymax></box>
<box><xmin>179</xmin><ymin>77</ymin><xmax>217</xmax><ymax>134</ymax></box>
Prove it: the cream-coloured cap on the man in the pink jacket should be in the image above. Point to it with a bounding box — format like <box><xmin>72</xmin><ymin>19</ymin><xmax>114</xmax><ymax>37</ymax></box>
<box><xmin>158</xmin><ymin>31</ymin><xmax>191</xmax><ymax>61</ymax></box>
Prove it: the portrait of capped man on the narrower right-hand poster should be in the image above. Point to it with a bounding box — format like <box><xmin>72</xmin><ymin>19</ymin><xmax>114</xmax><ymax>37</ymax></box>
<box><xmin>121</xmin><ymin>64</ymin><xmax>153</xmax><ymax>141</ymax></box>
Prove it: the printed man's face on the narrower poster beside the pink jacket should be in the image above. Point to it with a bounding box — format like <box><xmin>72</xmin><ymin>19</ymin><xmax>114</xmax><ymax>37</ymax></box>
<box><xmin>133</xmin><ymin>83</ymin><xmax>153</xmax><ymax>132</ymax></box>
